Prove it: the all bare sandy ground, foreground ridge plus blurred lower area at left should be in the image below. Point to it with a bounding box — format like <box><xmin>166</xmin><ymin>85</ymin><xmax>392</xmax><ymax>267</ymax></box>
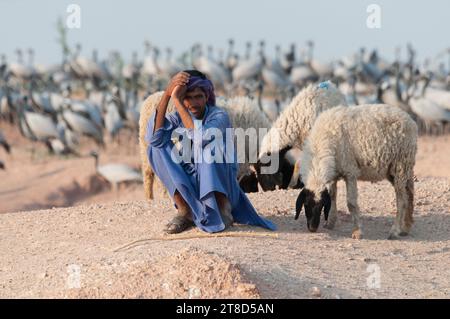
<box><xmin>0</xmin><ymin>123</ymin><xmax>450</xmax><ymax>298</ymax></box>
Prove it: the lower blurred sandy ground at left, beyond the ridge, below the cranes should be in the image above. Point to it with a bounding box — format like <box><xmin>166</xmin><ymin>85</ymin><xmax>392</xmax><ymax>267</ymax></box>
<box><xmin>0</xmin><ymin>123</ymin><xmax>144</xmax><ymax>213</ymax></box>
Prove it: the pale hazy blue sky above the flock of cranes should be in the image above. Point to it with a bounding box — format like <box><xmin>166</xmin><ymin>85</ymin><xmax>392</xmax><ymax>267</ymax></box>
<box><xmin>0</xmin><ymin>0</ymin><xmax>450</xmax><ymax>62</ymax></box>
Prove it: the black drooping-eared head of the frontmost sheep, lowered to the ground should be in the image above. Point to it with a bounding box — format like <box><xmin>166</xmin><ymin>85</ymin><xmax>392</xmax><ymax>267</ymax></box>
<box><xmin>295</xmin><ymin>188</ymin><xmax>331</xmax><ymax>233</ymax></box>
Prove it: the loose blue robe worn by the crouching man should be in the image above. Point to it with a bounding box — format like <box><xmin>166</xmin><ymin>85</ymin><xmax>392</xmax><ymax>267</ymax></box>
<box><xmin>145</xmin><ymin>106</ymin><xmax>276</xmax><ymax>233</ymax></box>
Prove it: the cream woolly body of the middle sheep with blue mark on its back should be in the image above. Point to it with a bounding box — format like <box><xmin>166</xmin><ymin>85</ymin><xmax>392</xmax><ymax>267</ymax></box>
<box><xmin>259</xmin><ymin>81</ymin><xmax>347</xmax><ymax>158</ymax></box>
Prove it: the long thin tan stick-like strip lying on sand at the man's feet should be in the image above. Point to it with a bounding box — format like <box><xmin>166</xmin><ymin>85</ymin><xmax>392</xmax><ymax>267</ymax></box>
<box><xmin>113</xmin><ymin>232</ymin><xmax>278</xmax><ymax>253</ymax></box>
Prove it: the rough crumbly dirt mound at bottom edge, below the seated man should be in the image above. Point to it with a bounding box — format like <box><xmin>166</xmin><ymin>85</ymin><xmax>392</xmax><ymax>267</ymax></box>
<box><xmin>65</xmin><ymin>248</ymin><xmax>259</xmax><ymax>299</ymax></box>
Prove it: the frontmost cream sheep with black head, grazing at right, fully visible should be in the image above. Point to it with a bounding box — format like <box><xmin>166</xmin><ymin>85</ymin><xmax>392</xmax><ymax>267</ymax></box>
<box><xmin>295</xmin><ymin>104</ymin><xmax>418</xmax><ymax>239</ymax></box>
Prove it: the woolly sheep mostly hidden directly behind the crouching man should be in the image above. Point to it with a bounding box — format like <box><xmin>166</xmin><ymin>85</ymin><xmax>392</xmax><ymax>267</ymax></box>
<box><xmin>139</xmin><ymin>92</ymin><xmax>279</xmax><ymax>200</ymax></box>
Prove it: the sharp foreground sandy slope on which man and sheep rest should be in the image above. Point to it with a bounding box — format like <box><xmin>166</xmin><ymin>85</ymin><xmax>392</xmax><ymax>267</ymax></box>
<box><xmin>0</xmin><ymin>178</ymin><xmax>450</xmax><ymax>298</ymax></box>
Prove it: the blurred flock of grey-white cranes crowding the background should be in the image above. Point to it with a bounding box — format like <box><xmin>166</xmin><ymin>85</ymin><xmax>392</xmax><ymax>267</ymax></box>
<box><xmin>0</xmin><ymin>40</ymin><xmax>450</xmax><ymax>188</ymax></box>
